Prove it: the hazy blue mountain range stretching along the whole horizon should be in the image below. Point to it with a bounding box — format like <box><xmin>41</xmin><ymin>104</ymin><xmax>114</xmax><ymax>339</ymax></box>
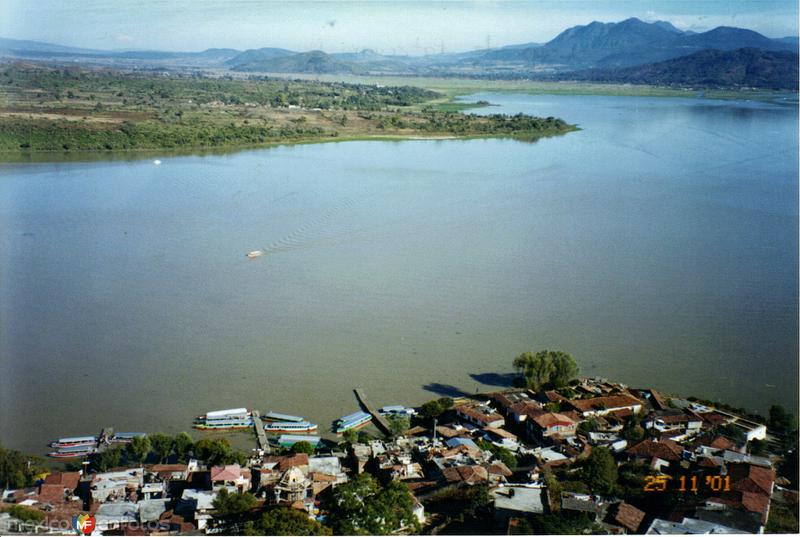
<box><xmin>0</xmin><ymin>18</ymin><xmax>798</xmax><ymax>87</ymax></box>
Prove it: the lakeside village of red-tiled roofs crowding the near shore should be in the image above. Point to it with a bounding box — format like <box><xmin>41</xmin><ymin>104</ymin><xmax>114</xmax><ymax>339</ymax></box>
<box><xmin>0</xmin><ymin>368</ymin><xmax>798</xmax><ymax>535</ymax></box>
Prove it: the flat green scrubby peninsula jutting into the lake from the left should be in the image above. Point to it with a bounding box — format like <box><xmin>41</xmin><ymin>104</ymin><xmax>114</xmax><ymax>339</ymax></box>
<box><xmin>0</xmin><ymin>64</ymin><xmax>576</xmax><ymax>156</ymax></box>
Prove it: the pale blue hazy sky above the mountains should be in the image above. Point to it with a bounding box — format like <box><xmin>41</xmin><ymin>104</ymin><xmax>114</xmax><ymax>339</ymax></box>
<box><xmin>0</xmin><ymin>0</ymin><xmax>798</xmax><ymax>54</ymax></box>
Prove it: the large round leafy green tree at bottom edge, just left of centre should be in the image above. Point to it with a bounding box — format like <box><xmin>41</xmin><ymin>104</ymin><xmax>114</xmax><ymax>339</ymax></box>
<box><xmin>328</xmin><ymin>473</ymin><xmax>419</xmax><ymax>535</ymax></box>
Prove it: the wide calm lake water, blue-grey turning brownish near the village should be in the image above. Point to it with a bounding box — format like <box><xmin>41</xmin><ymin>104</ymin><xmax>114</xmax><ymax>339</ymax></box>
<box><xmin>0</xmin><ymin>94</ymin><xmax>798</xmax><ymax>452</ymax></box>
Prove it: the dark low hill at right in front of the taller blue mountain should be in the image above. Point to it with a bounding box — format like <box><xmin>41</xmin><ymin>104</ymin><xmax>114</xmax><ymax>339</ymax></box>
<box><xmin>567</xmin><ymin>48</ymin><xmax>798</xmax><ymax>89</ymax></box>
